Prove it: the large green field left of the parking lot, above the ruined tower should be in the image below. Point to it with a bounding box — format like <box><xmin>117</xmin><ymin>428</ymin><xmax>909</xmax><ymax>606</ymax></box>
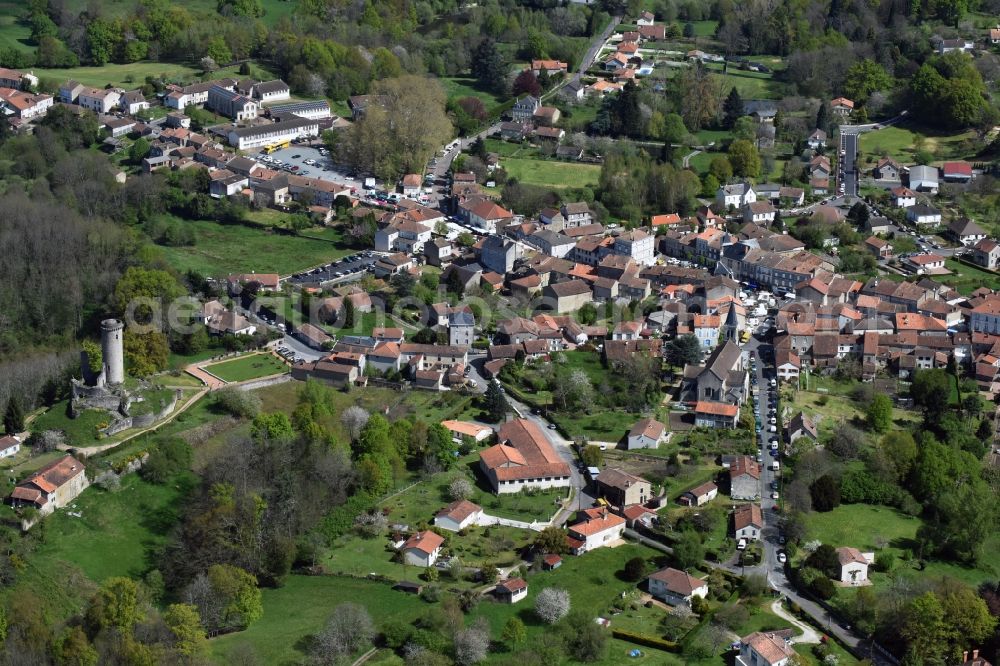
<box><xmin>159</xmin><ymin>220</ymin><xmax>352</xmax><ymax>276</ymax></box>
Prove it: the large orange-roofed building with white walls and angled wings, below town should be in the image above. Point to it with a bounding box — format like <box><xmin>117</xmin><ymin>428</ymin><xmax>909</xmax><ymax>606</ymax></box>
<box><xmin>479</xmin><ymin>419</ymin><xmax>571</xmax><ymax>493</ymax></box>
